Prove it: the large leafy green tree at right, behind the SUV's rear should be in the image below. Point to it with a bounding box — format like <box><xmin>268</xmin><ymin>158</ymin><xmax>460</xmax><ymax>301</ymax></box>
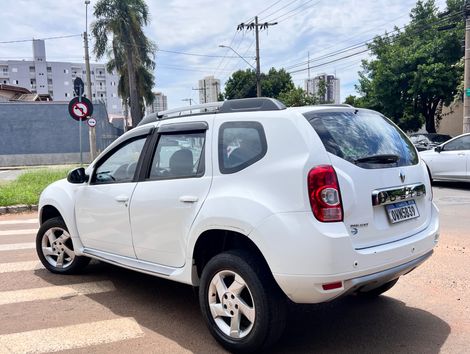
<box><xmin>357</xmin><ymin>0</ymin><xmax>464</xmax><ymax>133</ymax></box>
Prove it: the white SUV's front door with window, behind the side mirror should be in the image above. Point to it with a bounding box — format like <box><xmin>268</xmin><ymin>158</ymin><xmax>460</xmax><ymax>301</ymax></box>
<box><xmin>75</xmin><ymin>133</ymin><xmax>148</xmax><ymax>258</ymax></box>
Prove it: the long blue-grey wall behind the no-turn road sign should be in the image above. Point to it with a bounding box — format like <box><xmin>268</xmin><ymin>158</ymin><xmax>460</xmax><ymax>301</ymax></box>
<box><xmin>0</xmin><ymin>102</ymin><xmax>122</xmax><ymax>167</ymax></box>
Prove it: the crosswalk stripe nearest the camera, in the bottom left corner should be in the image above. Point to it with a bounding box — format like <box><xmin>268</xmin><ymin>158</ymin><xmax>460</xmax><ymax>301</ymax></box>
<box><xmin>0</xmin><ymin>317</ymin><xmax>144</xmax><ymax>354</ymax></box>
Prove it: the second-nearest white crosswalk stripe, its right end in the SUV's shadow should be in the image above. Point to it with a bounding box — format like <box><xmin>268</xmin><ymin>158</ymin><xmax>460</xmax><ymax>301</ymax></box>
<box><xmin>0</xmin><ymin>281</ymin><xmax>116</xmax><ymax>305</ymax></box>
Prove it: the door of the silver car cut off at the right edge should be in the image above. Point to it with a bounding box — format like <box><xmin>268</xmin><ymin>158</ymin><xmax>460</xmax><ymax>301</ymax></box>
<box><xmin>432</xmin><ymin>135</ymin><xmax>470</xmax><ymax>179</ymax></box>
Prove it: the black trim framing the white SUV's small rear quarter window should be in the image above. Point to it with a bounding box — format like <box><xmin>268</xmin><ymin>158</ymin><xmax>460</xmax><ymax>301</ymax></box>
<box><xmin>217</xmin><ymin>121</ymin><xmax>268</xmax><ymax>174</ymax></box>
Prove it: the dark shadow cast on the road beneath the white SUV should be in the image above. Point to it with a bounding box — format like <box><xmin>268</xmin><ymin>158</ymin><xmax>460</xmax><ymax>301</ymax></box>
<box><xmin>36</xmin><ymin>262</ymin><xmax>450</xmax><ymax>353</ymax></box>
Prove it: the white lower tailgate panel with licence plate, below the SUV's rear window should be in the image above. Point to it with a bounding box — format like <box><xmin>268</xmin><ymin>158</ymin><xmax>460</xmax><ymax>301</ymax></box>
<box><xmin>331</xmin><ymin>155</ymin><xmax>431</xmax><ymax>249</ymax></box>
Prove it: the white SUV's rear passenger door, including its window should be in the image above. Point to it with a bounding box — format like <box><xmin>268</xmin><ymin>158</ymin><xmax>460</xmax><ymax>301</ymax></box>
<box><xmin>130</xmin><ymin>122</ymin><xmax>212</xmax><ymax>267</ymax></box>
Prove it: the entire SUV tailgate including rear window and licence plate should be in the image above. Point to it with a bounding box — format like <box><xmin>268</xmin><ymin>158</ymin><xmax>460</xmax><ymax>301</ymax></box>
<box><xmin>304</xmin><ymin>108</ymin><xmax>431</xmax><ymax>249</ymax></box>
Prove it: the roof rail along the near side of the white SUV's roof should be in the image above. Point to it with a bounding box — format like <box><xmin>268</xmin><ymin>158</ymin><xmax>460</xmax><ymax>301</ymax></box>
<box><xmin>138</xmin><ymin>97</ymin><xmax>286</xmax><ymax>125</ymax></box>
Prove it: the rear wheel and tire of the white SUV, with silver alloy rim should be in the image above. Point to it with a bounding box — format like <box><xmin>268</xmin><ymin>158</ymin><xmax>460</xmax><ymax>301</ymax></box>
<box><xmin>199</xmin><ymin>250</ymin><xmax>286</xmax><ymax>353</ymax></box>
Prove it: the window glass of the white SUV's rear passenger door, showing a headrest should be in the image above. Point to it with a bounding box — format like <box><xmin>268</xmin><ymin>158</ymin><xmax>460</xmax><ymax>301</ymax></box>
<box><xmin>150</xmin><ymin>132</ymin><xmax>205</xmax><ymax>179</ymax></box>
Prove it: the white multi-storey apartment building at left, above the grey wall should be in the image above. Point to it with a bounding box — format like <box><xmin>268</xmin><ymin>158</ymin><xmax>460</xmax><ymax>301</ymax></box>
<box><xmin>0</xmin><ymin>39</ymin><xmax>122</xmax><ymax>115</ymax></box>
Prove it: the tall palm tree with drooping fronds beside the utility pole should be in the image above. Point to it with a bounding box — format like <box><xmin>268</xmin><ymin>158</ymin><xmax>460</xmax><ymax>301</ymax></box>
<box><xmin>92</xmin><ymin>0</ymin><xmax>155</xmax><ymax>126</ymax></box>
